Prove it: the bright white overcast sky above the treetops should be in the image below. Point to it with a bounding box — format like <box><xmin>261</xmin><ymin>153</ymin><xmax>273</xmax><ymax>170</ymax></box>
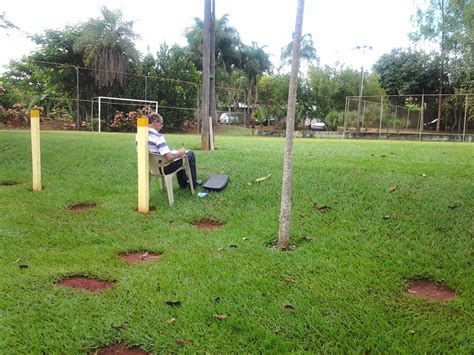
<box><xmin>0</xmin><ymin>0</ymin><xmax>426</xmax><ymax>72</ymax></box>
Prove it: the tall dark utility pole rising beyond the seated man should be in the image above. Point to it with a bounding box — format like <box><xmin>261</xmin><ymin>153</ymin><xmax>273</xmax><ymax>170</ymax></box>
<box><xmin>201</xmin><ymin>0</ymin><xmax>216</xmax><ymax>150</ymax></box>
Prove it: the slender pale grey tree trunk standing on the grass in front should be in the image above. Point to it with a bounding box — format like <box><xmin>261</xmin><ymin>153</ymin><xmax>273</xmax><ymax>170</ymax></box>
<box><xmin>277</xmin><ymin>0</ymin><xmax>304</xmax><ymax>250</ymax></box>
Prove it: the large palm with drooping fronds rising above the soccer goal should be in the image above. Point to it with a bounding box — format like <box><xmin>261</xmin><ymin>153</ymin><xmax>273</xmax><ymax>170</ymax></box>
<box><xmin>74</xmin><ymin>6</ymin><xmax>139</xmax><ymax>87</ymax></box>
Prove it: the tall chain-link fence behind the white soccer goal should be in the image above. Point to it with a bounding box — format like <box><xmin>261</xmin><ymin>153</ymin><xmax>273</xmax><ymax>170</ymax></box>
<box><xmin>0</xmin><ymin>62</ymin><xmax>249</xmax><ymax>132</ymax></box>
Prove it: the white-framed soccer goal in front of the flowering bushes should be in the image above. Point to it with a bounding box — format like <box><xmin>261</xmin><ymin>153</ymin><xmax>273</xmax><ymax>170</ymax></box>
<box><xmin>91</xmin><ymin>96</ymin><xmax>158</xmax><ymax>132</ymax></box>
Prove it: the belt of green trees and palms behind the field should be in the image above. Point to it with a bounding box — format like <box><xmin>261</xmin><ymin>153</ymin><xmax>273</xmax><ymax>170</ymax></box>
<box><xmin>0</xmin><ymin>0</ymin><xmax>474</xmax><ymax>128</ymax></box>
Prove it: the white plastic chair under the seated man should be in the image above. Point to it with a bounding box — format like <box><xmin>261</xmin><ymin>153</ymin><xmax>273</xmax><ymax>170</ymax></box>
<box><xmin>148</xmin><ymin>153</ymin><xmax>194</xmax><ymax>206</ymax></box>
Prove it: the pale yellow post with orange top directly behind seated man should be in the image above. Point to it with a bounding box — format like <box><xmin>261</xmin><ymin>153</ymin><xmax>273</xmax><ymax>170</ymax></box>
<box><xmin>137</xmin><ymin>117</ymin><xmax>150</xmax><ymax>213</ymax></box>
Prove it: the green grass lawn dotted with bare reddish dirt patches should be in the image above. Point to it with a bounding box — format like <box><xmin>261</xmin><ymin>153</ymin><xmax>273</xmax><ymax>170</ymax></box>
<box><xmin>0</xmin><ymin>131</ymin><xmax>474</xmax><ymax>354</ymax></box>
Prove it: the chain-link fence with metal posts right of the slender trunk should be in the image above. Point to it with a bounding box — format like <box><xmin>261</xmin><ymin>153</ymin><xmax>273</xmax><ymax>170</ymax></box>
<box><xmin>344</xmin><ymin>94</ymin><xmax>474</xmax><ymax>140</ymax></box>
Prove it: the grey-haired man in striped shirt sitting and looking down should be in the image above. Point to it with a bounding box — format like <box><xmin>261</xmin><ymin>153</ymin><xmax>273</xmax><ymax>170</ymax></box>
<box><xmin>148</xmin><ymin>112</ymin><xmax>202</xmax><ymax>189</ymax></box>
